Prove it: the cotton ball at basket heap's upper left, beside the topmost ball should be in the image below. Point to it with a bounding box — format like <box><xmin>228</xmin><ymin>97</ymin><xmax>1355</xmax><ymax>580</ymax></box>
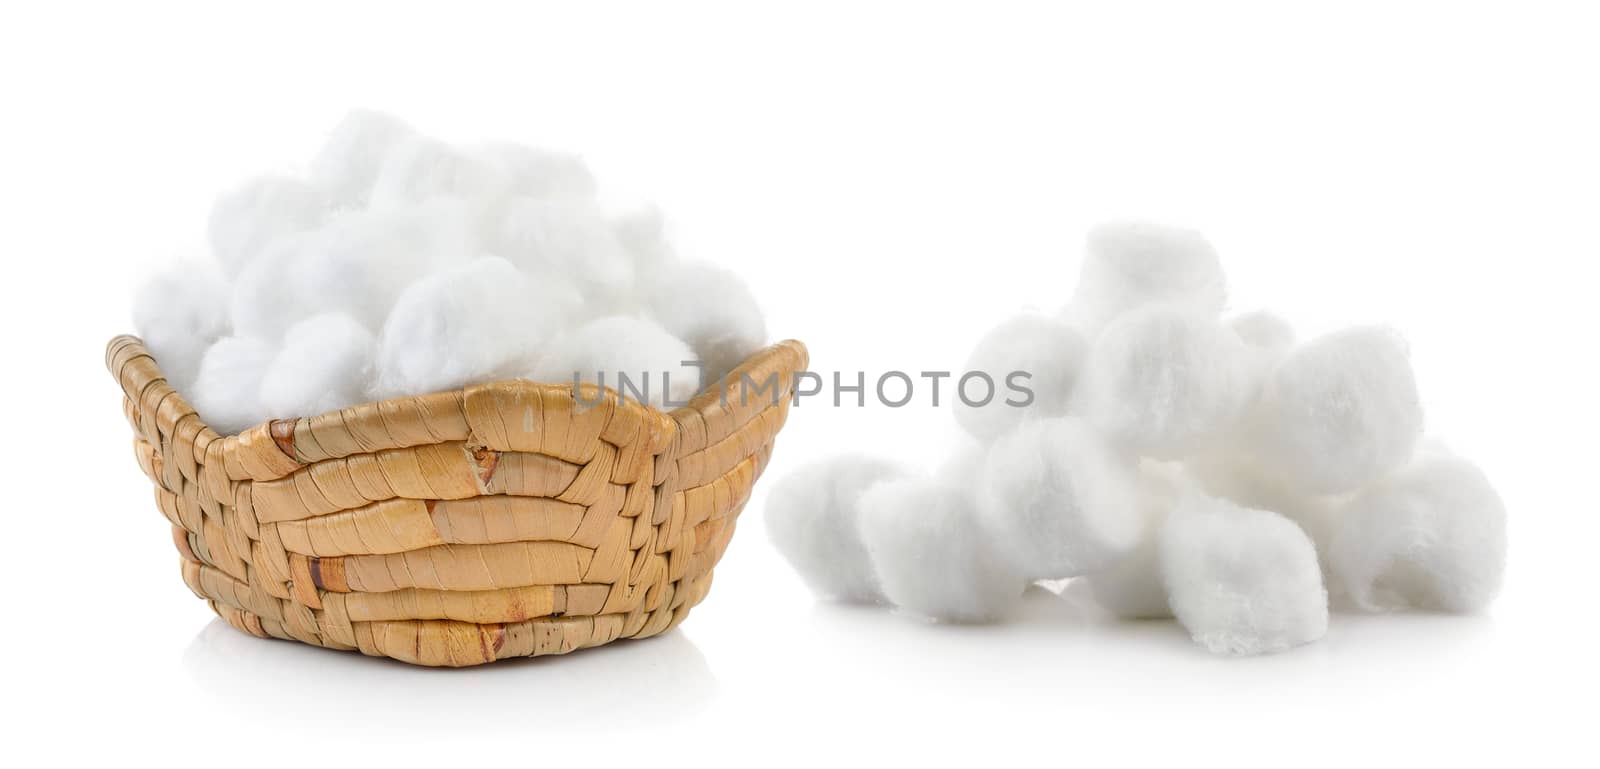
<box><xmin>206</xmin><ymin>176</ymin><xmax>328</xmax><ymax>277</ymax></box>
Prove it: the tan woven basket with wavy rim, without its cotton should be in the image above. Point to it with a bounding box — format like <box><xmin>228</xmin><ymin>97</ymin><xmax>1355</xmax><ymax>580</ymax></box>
<box><xmin>106</xmin><ymin>336</ymin><xmax>806</xmax><ymax>667</ymax></box>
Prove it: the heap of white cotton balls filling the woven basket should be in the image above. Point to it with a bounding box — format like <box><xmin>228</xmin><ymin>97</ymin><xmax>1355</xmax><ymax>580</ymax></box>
<box><xmin>133</xmin><ymin>112</ymin><xmax>765</xmax><ymax>433</ymax></box>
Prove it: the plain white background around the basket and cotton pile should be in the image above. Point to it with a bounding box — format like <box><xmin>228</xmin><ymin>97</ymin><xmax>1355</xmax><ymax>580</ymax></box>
<box><xmin>0</xmin><ymin>2</ymin><xmax>1600</xmax><ymax>766</ymax></box>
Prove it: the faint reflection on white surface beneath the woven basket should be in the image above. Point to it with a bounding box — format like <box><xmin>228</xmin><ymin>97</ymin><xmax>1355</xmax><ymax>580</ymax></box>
<box><xmin>182</xmin><ymin>619</ymin><xmax>717</xmax><ymax>735</ymax></box>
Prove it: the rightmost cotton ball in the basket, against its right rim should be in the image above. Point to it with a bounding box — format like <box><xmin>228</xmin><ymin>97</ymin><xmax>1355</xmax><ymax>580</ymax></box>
<box><xmin>648</xmin><ymin>262</ymin><xmax>766</xmax><ymax>382</ymax></box>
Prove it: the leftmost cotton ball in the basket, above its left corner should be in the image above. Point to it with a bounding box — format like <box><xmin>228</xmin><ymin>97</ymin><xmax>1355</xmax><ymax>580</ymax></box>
<box><xmin>133</xmin><ymin>262</ymin><xmax>229</xmax><ymax>395</ymax></box>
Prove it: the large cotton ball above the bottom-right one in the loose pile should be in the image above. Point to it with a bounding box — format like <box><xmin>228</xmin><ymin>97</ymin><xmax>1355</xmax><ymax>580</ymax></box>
<box><xmin>1246</xmin><ymin>326</ymin><xmax>1422</xmax><ymax>494</ymax></box>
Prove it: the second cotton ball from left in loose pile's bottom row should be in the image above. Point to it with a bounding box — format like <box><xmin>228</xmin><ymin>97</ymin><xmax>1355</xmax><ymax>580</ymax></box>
<box><xmin>859</xmin><ymin>478</ymin><xmax>1029</xmax><ymax>622</ymax></box>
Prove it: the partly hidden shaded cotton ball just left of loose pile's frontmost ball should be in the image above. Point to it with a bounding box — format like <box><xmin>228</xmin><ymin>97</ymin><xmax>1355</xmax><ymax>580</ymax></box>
<box><xmin>1082</xmin><ymin>460</ymin><xmax>1194</xmax><ymax>619</ymax></box>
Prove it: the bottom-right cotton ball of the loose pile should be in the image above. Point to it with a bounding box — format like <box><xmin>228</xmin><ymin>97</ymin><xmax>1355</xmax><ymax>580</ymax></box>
<box><xmin>1330</xmin><ymin>449</ymin><xmax>1506</xmax><ymax>612</ymax></box>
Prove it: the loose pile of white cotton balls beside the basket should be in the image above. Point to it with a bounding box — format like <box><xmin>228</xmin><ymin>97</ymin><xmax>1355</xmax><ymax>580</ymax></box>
<box><xmin>766</xmin><ymin>222</ymin><xmax>1506</xmax><ymax>654</ymax></box>
